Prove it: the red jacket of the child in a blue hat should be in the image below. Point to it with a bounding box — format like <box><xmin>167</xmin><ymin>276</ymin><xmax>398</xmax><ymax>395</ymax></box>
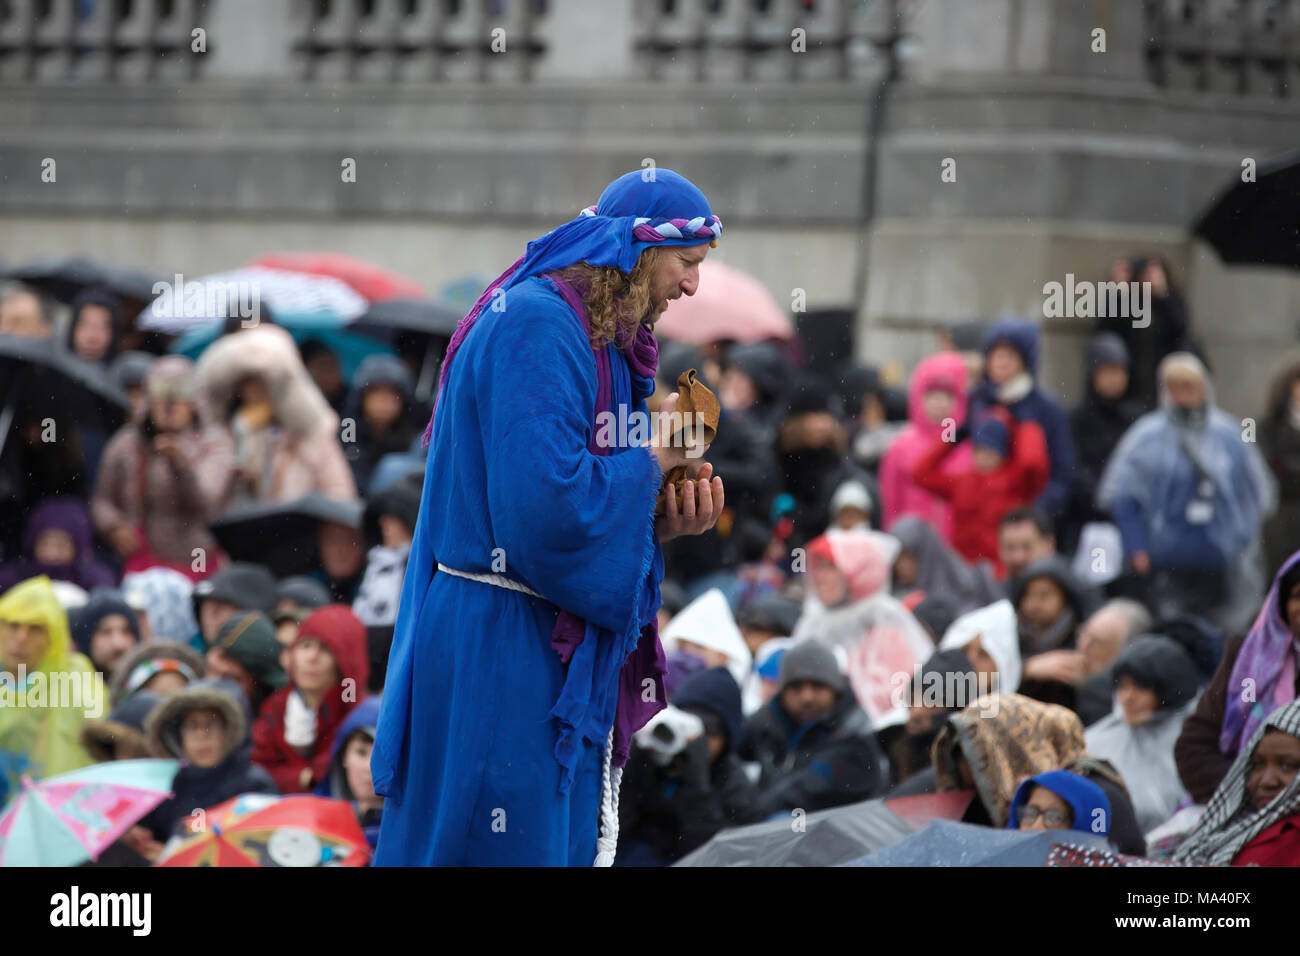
<box><xmin>911</xmin><ymin>421</ymin><xmax>1050</xmax><ymax>578</ymax></box>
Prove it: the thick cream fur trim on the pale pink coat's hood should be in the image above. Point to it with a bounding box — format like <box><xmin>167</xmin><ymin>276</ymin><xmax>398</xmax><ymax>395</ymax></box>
<box><xmin>196</xmin><ymin>325</ymin><xmax>338</xmax><ymax>437</ymax></box>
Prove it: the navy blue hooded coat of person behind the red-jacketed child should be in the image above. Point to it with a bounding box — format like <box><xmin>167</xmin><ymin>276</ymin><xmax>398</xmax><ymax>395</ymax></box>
<box><xmin>966</xmin><ymin>319</ymin><xmax>1075</xmax><ymax>515</ymax></box>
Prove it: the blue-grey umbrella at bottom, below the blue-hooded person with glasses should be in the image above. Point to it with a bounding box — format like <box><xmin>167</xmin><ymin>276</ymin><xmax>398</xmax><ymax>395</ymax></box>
<box><xmin>845</xmin><ymin>819</ymin><xmax>1109</xmax><ymax>866</ymax></box>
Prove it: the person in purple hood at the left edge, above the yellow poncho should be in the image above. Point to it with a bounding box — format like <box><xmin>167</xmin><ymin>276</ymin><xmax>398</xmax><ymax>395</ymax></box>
<box><xmin>0</xmin><ymin>498</ymin><xmax>117</xmax><ymax>593</ymax></box>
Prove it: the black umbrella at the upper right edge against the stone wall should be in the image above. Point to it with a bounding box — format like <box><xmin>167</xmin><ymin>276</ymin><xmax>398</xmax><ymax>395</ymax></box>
<box><xmin>1192</xmin><ymin>151</ymin><xmax>1300</xmax><ymax>269</ymax></box>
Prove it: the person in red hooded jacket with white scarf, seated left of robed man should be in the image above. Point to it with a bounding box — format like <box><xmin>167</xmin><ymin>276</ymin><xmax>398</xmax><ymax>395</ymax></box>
<box><xmin>252</xmin><ymin>605</ymin><xmax>368</xmax><ymax>793</ymax></box>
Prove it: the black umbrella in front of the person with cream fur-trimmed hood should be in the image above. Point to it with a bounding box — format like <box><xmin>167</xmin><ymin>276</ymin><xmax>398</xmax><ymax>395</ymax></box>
<box><xmin>208</xmin><ymin>494</ymin><xmax>365</xmax><ymax>578</ymax></box>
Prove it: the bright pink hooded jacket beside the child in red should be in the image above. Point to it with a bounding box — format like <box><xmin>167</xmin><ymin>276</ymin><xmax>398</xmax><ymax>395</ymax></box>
<box><xmin>879</xmin><ymin>351</ymin><xmax>971</xmax><ymax>544</ymax></box>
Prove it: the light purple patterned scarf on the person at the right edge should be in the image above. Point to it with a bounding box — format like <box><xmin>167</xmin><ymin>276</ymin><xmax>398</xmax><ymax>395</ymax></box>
<box><xmin>1219</xmin><ymin>551</ymin><xmax>1300</xmax><ymax>754</ymax></box>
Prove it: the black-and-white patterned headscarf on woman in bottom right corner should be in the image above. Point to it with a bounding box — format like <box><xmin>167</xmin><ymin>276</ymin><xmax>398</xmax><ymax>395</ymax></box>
<box><xmin>1174</xmin><ymin>700</ymin><xmax>1300</xmax><ymax>865</ymax></box>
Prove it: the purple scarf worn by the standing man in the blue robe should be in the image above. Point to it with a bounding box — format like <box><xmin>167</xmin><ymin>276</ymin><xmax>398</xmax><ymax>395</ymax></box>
<box><xmin>547</xmin><ymin>274</ymin><xmax>667</xmax><ymax>767</ymax></box>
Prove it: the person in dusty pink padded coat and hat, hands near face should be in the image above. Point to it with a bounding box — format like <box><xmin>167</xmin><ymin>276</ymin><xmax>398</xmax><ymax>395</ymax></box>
<box><xmin>91</xmin><ymin>355</ymin><xmax>234</xmax><ymax>580</ymax></box>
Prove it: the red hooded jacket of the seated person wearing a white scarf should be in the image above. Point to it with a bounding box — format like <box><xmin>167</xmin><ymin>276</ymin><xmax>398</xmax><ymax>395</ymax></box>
<box><xmin>252</xmin><ymin>605</ymin><xmax>369</xmax><ymax>793</ymax></box>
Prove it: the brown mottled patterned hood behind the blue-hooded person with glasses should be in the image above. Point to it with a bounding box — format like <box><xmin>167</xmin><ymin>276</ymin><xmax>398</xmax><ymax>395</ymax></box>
<box><xmin>931</xmin><ymin>693</ymin><xmax>1084</xmax><ymax>827</ymax></box>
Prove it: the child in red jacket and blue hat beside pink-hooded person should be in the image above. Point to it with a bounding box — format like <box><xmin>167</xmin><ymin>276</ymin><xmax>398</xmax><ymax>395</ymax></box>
<box><xmin>913</xmin><ymin>412</ymin><xmax>1048</xmax><ymax>576</ymax></box>
